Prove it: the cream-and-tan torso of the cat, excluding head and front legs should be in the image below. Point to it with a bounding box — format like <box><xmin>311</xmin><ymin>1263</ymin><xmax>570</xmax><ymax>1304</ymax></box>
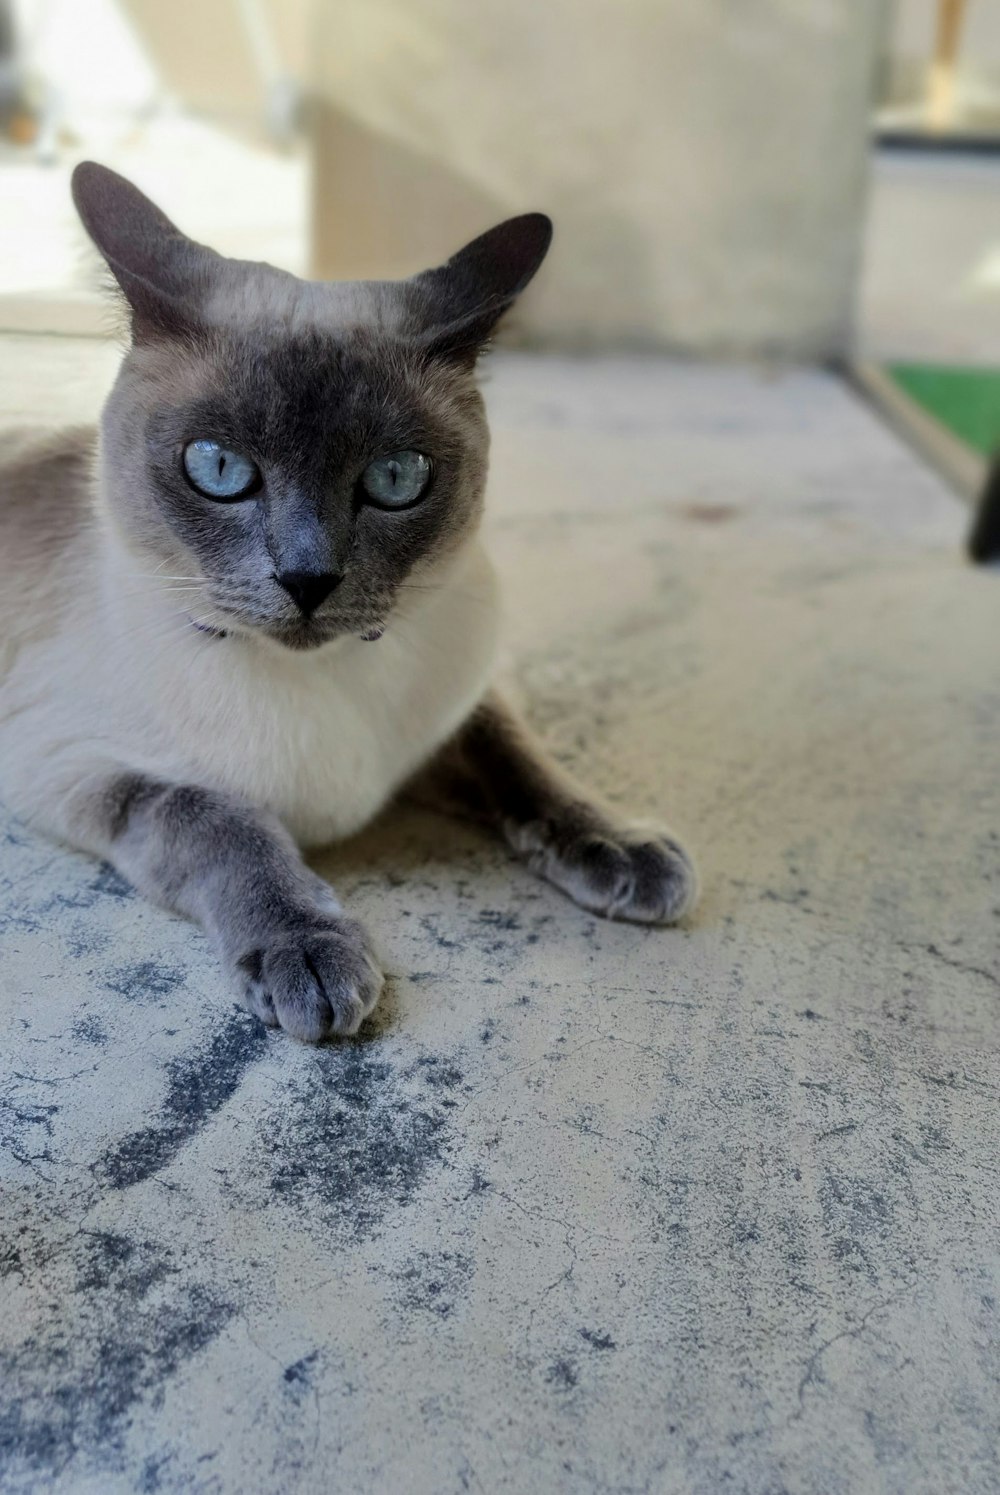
<box><xmin>0</xmin><ymin>431</ymin><xmax>498</xmax><ymax>848</ymax></box>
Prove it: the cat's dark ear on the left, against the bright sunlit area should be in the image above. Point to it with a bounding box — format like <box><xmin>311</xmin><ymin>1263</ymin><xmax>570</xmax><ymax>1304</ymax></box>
<box><xmin>72</xmin><ymin>161</ymin><xmax>221</xmax><ymax>338</ymax></box>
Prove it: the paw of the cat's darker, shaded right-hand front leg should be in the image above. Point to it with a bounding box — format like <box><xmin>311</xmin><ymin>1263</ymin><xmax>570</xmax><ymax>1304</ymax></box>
<box><xmin>507</xmin><ymin>813</ymin><xmax>698</xmax><ymax>924</ymax></box>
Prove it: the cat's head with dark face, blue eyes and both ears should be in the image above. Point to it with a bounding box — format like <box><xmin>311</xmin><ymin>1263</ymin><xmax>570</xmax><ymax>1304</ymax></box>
<box><xmin>73</xmin><ymin>161</ymin><xmax>552</xmax><ymax>649</ymax></box>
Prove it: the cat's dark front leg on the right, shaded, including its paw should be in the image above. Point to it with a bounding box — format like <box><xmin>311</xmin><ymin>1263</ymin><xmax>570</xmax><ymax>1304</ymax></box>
<box><xmin>414</xmin><ymin>694</ymin><xmax>698</xmax><ymax>924</ymax></box>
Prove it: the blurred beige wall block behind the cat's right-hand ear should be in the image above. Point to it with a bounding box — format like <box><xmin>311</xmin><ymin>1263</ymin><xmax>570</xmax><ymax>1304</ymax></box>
<box><xmin>314</xmin><ymin>0</ymin><xmax>882</xmax><ymax>357</ymax></box>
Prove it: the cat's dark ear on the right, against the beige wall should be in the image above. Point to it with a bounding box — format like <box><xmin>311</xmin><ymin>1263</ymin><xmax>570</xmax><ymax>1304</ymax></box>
<box><xmin>410</xmin><ymin>212</ymin><xmax>552</xmax><ymax>363</ymax></box>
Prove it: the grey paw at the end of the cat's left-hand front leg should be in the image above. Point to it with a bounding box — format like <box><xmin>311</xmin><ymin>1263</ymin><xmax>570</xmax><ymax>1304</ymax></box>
<box><xmin>235</xmin><ymin>915</ymin><xmax>383</xmax><ymax>1044</ymax></box>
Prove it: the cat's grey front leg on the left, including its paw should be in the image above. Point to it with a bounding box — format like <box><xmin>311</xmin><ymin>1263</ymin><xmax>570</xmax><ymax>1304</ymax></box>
<box><xmin>54</xmin><ymin>768</ymin><xmax>383</xmax><ymax>1042</ymax></box>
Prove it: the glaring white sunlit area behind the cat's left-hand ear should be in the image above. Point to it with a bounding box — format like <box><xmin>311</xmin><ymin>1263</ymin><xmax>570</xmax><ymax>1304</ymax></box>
<box><xmin>0</xmin><ymin>0</ymin><xmax>306</xmax><ymax>332</ymax></box>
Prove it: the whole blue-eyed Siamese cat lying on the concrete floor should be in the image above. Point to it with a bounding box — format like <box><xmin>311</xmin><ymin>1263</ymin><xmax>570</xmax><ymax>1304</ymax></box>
<box><xmin>0</xmin><ymin>163</ymin><xmax>695</xmax><ymax>1041</ymax></box>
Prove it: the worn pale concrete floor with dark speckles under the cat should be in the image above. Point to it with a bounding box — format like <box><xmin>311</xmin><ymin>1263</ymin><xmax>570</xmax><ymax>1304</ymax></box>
<box><xmin>0</xmin><ymin>344</ymin><xmax>1000</xmax><ymax>1495</ymax></box>
